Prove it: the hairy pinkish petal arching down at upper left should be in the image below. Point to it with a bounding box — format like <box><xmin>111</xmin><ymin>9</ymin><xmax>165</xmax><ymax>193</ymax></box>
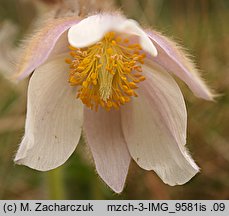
<box><xmin>16</xmin><ymin>17</ymin><xmax>79</xmax><ymax>79</ymax></box>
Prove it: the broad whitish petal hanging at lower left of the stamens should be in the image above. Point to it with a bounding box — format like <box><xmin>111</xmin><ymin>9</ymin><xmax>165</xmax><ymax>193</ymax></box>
<box><xmin>15</xmin><ymin>55</ymin><xmax>83</xmax><ymax>171</ymax></box>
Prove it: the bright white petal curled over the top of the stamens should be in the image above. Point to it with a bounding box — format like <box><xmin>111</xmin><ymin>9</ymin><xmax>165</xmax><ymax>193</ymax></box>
<box><xmin>68</xmin><ymin>14</ymin><xmax>157</xmax><ymax>56</ymax></box>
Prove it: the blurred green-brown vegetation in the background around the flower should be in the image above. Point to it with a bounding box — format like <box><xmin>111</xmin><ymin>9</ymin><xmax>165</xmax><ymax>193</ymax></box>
<box><xmin>0</xmin><ymin>0</ymin><xmax>229</xmax><ymax>199</ymax></box>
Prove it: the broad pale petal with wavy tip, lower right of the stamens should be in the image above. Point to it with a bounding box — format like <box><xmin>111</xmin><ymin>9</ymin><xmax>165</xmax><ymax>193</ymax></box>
<box><xmin>122</xmin><ymin>67</ymin><xmax>199</xmax><ymax>185</ymax></box>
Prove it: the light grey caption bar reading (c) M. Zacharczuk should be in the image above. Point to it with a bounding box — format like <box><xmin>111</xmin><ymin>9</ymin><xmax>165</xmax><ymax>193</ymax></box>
<box><xmin>0</xmin><ymin>200</ymin><xmax>229</xmax><ymax>216</ymax></box>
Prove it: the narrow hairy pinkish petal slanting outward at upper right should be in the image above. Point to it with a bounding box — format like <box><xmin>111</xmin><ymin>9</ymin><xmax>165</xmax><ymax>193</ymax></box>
<box><xmin>148</xmin><ymin>31</ymin><xmax>213</xmax><ymax>100</ymax></box>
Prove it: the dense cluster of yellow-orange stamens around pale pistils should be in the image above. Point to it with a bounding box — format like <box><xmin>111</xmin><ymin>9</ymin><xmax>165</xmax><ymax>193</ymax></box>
<box><xmin>66</xmin><ymin>32</ymin><xmax>145</xmax><ymax>111</ymax></box>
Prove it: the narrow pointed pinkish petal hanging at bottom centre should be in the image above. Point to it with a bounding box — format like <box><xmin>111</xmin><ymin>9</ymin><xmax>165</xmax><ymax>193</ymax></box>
<box><xmin>84</xmin><ymin>109</ymin><xmax>130</xmax><ymax>193</ymax></box>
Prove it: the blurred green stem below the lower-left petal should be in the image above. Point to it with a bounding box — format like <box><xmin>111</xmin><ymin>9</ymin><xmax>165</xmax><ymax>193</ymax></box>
<box><xmin>47</xmin><ymin>167</ymin><xmax>65</xmax><ymax>200</ymax></box>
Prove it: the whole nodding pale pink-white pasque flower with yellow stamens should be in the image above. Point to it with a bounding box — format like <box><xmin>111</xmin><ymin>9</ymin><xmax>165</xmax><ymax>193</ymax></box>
<box><xmin>15</xmin><ymin>14</ymin><xmax>212</xmax><ymax>192</ymax></box>
